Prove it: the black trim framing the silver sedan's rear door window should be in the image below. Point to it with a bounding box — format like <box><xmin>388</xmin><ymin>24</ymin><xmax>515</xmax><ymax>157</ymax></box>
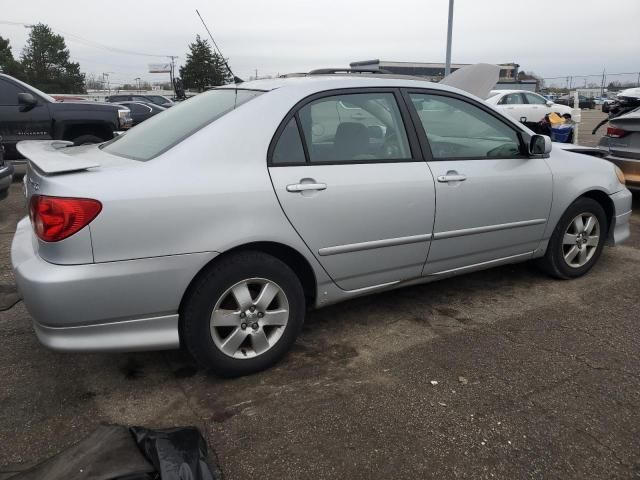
<box><xmin>267</xmin><ymin>87</ymin><xmax>425</xmax><ymax>167</ymax></box>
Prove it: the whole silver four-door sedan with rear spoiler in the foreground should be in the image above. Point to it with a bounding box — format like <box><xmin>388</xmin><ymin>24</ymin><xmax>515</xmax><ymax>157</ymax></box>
<box><xmin>12</xmin><ymin>74</ymin><xmax>631</xmax><ymax>375</ymax></box>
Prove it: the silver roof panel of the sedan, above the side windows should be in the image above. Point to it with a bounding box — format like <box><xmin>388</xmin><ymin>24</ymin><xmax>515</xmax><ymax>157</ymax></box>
<box><xmin>218</xmin><ymin>73</ymin><xmax>462</xmax><ymax>95</ymax></box>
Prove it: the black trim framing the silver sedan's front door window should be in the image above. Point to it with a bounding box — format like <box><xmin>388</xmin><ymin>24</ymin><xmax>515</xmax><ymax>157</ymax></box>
<box><xmin>401</xmin><ymin>88</ymin><xmax>532</xmax><ymax>162</ymax></box>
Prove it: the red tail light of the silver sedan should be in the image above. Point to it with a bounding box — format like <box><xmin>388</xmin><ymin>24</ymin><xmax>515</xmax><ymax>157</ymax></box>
<box><xmin>29</xmin><ymin>195</ymin><xmax>102</xmax><ymax>242</ymax></box>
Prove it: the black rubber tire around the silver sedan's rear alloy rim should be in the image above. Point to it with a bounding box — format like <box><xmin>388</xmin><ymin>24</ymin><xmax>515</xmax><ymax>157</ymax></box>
<box><xmin>180</xmin><ymin>251</ymin><xmax>305</xmax><ymax>377</ymax></box>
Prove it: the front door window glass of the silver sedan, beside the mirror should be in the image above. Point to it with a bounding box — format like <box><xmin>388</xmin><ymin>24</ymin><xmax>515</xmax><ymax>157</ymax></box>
<box><xmin>409</xmin><ymin>93</ymin><xmax>520</xmax><ymax>160</ymax></box>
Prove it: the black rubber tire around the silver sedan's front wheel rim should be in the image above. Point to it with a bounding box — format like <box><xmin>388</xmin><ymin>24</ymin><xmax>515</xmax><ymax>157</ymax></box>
<box><xmin>538</xmin><ymin>197</ymin><xmax>609</xmax><ymax>280</ymax></box>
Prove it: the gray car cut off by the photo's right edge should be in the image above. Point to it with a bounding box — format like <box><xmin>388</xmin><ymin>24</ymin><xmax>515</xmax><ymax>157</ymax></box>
<box><xmin>598</xmin><ymin>108</ymin><xmax>640</xmax><ymax>190</ymax></box>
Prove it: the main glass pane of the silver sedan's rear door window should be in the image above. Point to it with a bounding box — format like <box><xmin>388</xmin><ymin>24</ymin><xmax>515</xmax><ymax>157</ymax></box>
<box><xmin>298</xmin><ymin>93</ymin><xmax>411</xmax><ymax>163</ymax></box>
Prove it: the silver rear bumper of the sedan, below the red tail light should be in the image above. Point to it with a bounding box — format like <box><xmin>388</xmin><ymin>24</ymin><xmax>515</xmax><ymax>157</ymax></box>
<box><xmin>11</xmin><ymin>219</ymin><xmax>217</xmax><ymax>351</ymax></box>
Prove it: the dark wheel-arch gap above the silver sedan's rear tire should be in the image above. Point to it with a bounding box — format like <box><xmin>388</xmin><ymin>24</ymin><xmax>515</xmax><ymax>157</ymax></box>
<box><xmin>179</xmin><ymin>242</ymin><xmax>317</xmax><ymax>313</ymax></box>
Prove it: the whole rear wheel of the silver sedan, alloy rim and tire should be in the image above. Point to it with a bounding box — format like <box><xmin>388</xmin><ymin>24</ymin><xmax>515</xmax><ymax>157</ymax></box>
<box><xmin>181</xmin><ymin>252</ymin><xmax>305</xmax><ymax>377</ymax></box>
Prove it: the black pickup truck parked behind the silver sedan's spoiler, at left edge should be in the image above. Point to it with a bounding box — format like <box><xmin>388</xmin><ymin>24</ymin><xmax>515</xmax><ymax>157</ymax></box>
<box><xmin>0</xmin><ymin>74</ymin><xmax>131</xmax><ymax>163</ymax></box>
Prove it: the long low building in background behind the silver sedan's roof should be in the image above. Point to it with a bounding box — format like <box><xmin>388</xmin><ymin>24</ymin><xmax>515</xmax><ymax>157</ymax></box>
<box><xmin>349</xmin><ymin>59</ymin><xmax>537</xmax><ymax>91</ymax></box>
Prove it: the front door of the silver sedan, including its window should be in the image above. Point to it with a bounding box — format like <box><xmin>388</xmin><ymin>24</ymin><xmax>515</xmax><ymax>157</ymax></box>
<box><xmin>408</xmin><ymin>92</ymin><xmax>552</xmax><ymax>275</ymax></box>
